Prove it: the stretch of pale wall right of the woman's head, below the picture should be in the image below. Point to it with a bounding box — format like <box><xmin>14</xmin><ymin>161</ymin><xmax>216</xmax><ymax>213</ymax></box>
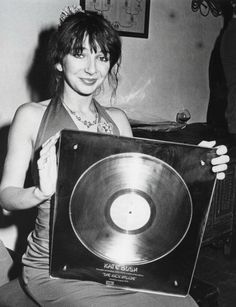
<box><xmin>120</xmin><ymin>0</ymin><xmax>221</xmax><ymax>121</ymax></box>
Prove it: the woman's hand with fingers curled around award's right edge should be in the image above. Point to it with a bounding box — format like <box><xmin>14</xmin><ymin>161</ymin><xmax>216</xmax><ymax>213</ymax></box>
<box><xmin>199</xmin><ymin>141</ymin><xmax>229</xmax><ymax>180</ymax></box>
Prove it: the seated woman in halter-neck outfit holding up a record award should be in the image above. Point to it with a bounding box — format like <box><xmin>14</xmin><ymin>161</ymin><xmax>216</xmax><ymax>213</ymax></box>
<box><xmin>0</xmin><ymin>10</ymin><xmax>228</xmax><ymax>307</ymax></box>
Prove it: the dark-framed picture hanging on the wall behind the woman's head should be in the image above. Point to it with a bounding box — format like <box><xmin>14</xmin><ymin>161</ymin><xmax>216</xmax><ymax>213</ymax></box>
<box><xmin>80</xmin><ymin>0</ymin><xmax>150</xmax><ymax>38</ymax></box>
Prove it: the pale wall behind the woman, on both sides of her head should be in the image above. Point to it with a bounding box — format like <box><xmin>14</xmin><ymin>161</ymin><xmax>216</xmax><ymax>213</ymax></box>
<box><xmin>0</xmin><ymin>0</ymin><xmax>222</xmax><ymax>248</ymax></box>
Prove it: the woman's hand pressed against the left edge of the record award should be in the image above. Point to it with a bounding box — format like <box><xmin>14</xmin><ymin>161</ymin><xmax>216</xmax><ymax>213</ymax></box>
<box><xmin>35</xmin><ymin>133</ymin><xmax>60</xmax><ymax>199</ymax></box>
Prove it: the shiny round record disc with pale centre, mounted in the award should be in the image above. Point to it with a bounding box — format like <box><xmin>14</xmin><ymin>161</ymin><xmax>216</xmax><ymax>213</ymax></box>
<box><xmin>69</xmin><ymin>153</ymin><xmax>193</xmax><ymax>265</ymax></box>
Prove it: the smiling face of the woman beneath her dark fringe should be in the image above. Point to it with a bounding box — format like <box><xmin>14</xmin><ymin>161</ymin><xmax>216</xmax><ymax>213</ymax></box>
<box><xmin>57</xmin><ymin>37</ymin><xmax>110</xmax><ymax>96</ymax></box>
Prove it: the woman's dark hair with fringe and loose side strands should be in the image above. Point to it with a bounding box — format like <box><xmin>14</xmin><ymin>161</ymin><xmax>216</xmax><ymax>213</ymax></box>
<box><xmin>48</xmin><ymin>11</ymin><xmax>122</xmax><ymax>97</ymax></box>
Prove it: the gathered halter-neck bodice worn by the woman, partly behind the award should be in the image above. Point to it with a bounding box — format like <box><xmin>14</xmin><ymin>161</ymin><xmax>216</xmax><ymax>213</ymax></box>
<box><xmin>22</xmin><ymin>99</ymin><xmax>120</xmax><ymax>270</ymax></box>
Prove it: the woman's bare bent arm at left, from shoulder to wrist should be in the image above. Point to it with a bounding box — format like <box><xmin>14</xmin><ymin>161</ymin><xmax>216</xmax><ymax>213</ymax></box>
<box><xmin>0</xmin><ymin>103</ymin><xmax>54</xmax><ymax>210</ymax></box>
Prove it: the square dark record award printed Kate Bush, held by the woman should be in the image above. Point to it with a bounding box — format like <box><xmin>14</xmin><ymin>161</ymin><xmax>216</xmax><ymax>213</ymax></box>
<box><xmin>50</xmin><ymin>130</ymin><xmax>216</xmax><ymax>296</ymax></box>
